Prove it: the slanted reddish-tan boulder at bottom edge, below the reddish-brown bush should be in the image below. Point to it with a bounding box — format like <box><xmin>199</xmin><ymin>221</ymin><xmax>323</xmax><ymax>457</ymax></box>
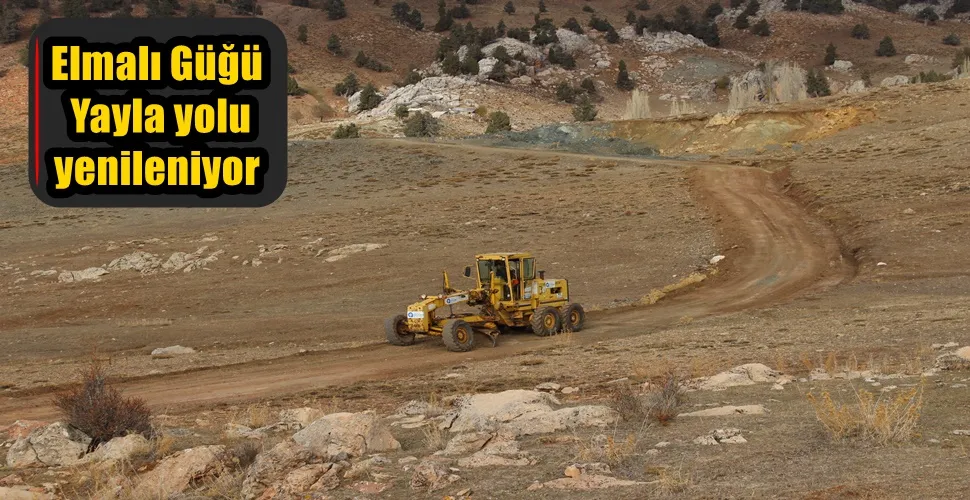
<box><xmin>132</xmin><ymin>445</ymin><xmax>230</xmax><ymax>498</ymax></box>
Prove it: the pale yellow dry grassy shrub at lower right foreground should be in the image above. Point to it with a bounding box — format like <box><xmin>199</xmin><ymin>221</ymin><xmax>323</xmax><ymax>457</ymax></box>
<box><xmin>808</xmin><ymin>382</ymin><xmax>923</xmax><ymax>444</ymax></box>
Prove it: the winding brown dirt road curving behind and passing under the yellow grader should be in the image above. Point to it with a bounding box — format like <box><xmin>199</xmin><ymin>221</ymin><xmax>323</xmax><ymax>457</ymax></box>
<box><xmin>0</xmin><ymin>151</ymin><xmax>853</xmax><ymax>424</ymax></box>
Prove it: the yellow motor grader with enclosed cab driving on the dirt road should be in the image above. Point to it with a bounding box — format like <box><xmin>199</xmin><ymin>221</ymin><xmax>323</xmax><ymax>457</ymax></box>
<box><xmin>384</xmin><ymin>253</ymin><xmax>586</xmax><ymax>352</ymax></box>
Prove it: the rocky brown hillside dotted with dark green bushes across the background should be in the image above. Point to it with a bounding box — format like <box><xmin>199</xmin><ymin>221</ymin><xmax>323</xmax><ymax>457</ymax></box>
<box><xmin>0</xmin><ymin>0</ymin><xmax>970</xmax><ymax>158</ymax></box>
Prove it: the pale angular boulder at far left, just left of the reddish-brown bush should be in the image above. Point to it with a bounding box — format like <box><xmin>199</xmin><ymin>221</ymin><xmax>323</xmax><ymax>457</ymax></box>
<box><xmin>7</xmin><ymin>422</ymin><xmax>91</xmax><ymax>469</ymax></box>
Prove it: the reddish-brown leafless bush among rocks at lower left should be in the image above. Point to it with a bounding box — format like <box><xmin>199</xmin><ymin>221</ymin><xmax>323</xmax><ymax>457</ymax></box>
<box><xmin>54</xmin><ymin>361</ymin><xmax>152</xmax><ymax>451</ymax></box>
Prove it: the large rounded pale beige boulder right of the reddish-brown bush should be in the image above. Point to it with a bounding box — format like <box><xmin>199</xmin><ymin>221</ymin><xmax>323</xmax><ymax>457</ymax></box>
<box><xmin>293</xmin><ymin>411</ymin><xmax>401</xmax><ymax>457</ymax></box>
